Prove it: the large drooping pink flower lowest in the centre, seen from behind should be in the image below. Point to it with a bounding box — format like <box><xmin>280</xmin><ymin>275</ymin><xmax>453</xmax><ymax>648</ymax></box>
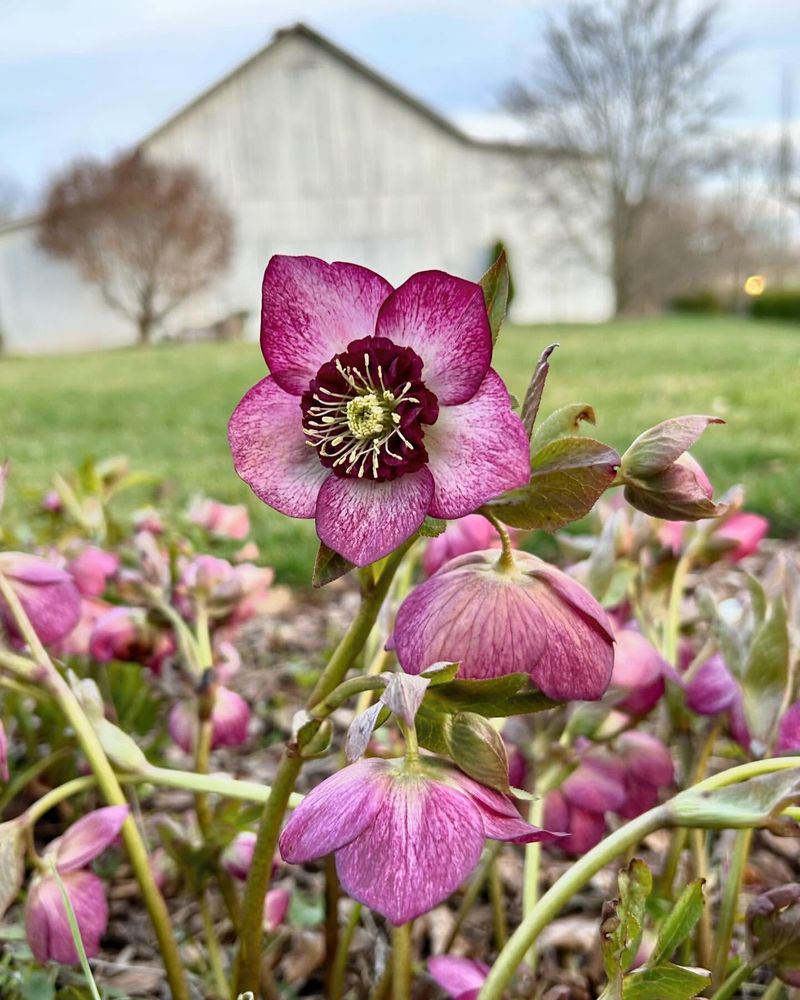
<box><xmin>279</xmin><ymin>758</ymin><xmax>555</xmax><ymax>925</ymax></box>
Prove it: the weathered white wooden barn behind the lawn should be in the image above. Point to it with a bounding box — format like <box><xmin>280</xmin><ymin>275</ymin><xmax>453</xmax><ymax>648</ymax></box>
<box><xmin>0</xmin><ymin>25</ymin><xmax>613</xmax><ymax>353</ymax></box>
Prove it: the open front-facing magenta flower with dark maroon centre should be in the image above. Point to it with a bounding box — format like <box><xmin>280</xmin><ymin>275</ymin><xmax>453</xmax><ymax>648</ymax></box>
<box><xmin>228</xmin><ymin>256</ymin><xmax>530</xmax><ymax>566</ymax></box>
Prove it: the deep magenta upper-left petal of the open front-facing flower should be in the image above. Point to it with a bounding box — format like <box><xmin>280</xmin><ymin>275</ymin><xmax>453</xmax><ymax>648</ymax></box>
<box><xmin>261</xmin><ymin>256</ymin><xmax>392</xmax><ymax>396</ymax></box>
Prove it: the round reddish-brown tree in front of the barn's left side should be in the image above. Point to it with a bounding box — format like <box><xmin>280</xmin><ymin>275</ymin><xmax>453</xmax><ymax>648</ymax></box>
<box><xmin>39</xmin><ymin>154</ymin><xmax>233</xmax><ymax>344</ymax></box>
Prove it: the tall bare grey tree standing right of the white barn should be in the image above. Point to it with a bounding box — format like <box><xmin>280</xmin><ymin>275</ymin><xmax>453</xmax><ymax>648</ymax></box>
<box><xmin>507</xmin><ymin>0</ymin><xmax>722</xmax><ymax>313</ymax></box>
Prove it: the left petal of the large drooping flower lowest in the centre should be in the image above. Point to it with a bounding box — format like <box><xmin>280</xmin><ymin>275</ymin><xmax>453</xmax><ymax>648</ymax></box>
<box><xmin>278</xmin><ymin>757</ymin><xmax>391</xmax><ymax>864</ymax></box>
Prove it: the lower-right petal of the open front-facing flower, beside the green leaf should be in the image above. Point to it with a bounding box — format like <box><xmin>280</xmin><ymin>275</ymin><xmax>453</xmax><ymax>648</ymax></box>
<box><xmin>423</xmin><ymin>369</ymin><xmax>531</xmax><ymax>518</ymax></box>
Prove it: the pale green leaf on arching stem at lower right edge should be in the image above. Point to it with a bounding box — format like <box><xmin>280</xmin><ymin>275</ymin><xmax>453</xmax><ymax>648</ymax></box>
<box><xmin>666</xmin><ymin>768</ymin><xmax>800</xmax><ymax>835</ymax></box>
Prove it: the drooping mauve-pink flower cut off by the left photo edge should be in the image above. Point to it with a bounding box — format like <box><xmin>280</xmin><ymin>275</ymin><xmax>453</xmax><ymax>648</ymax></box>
<box><xmin>0</xmin><ymin>552</ymin><xmax>81</xmax><ymax>643</ymax></box>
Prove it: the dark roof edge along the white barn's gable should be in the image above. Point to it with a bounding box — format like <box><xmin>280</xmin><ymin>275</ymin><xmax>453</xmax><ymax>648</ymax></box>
<box><xmin>137</xmin><ymin>22</ymin><xmax>540</xmax><ymax>153</ymax></box>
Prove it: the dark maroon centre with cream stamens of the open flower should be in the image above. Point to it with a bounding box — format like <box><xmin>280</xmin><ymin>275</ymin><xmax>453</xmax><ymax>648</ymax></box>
<box><xmin>301</xmin><ymin>337</ymin><xmax>439</xmax><ymax>482</ymax></box>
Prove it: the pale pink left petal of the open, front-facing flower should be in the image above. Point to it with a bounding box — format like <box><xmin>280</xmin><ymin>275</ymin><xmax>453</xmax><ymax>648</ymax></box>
<box><xmin>228</xmin><ymin>378</ymin><xmax>328</xmax><ymax>517</ymax></box>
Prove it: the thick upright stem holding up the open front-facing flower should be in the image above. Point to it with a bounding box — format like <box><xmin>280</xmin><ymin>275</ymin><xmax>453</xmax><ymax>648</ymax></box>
<box><xmin>233</xmin><ymin>539</ymin><xmax>414</xmax><ymax>997</ymax></box>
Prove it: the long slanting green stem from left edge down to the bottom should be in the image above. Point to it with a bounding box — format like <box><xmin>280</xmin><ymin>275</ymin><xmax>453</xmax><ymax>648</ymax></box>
<box><xmin>0</xmin><ymin>573</ymin><xmax>189</xmax><ymax>1000</ymax></box>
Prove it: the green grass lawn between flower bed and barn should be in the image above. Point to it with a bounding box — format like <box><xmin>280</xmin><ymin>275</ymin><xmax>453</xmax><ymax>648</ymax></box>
<box><xmin>0</xmin><ymin>317</ymin><xmax>800</xmax><ymax>583</ymax></box>
